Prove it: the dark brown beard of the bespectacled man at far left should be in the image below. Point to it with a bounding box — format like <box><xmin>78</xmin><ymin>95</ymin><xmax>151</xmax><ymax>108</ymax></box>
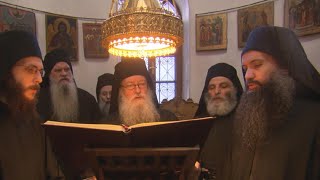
<box><xmin>0</xmin><ymin>75</ymin><xmax>40</xmax><ymax>121</ymax></box>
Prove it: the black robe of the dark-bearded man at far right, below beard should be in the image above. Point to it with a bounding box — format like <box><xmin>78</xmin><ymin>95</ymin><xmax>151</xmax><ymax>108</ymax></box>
<box><xmin>232</xmin><ymin>98</ymin><xmax>320</xmax><ymax>180</ymax></box>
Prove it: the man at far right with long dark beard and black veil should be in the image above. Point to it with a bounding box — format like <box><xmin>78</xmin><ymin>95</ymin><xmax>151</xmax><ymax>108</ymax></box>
<box><xmin>230</xmin><ymin>27</ymin><xmax>320</xmax><ymax>180</ymax></box>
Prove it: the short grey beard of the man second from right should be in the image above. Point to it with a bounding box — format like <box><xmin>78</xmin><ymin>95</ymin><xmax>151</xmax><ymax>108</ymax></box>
<box><xmin>204</xmin><ymin>90</ymin><xmax>237</xmax><ymax>116</ymax></box>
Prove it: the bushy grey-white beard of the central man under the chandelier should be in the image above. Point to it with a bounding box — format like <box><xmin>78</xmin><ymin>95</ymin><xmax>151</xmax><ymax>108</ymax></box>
<box><xmin>119</xmin><ymin>89</ymin><xmax>160</xmax><ymax>126</ymax></box>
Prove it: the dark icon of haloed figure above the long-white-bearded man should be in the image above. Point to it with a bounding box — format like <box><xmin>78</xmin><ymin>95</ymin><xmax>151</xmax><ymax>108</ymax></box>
<box><xmin>46</xmin><ymin>15</ymin><xmax>78</xmax><ymax>61</ymax></box>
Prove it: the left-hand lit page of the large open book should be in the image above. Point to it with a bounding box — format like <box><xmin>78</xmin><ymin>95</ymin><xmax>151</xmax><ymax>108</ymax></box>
<box><xmin>44</xmin><ymin>121</ymin><xmax>124</xmax><ymax>131</ymax></box>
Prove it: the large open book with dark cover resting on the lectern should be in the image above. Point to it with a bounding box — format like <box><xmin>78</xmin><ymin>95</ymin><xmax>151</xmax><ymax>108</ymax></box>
<box><xmin>43</xmin><ymin>117</ymin><xmax>213</xmax><ymax>147</ymax></box>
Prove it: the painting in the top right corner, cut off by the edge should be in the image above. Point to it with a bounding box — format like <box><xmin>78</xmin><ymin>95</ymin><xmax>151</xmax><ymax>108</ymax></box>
<box><xmin>284</xmin><ymin>0</ymin><xmax>320</xmax><ymax>36</ymax></box>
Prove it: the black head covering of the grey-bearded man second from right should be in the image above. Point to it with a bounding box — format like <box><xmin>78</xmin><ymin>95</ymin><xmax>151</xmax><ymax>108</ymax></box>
<box><xmin>195</xmin><ymin>63</ymin><xmax>243</xmax><ymax>117</ymax></box>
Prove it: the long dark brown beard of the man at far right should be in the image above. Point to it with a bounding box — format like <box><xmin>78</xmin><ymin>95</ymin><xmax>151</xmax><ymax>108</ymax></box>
<box><xmin>235</xmin><ymin>72</ymin><xmax>295</xmax><ymax>150</ymax></box>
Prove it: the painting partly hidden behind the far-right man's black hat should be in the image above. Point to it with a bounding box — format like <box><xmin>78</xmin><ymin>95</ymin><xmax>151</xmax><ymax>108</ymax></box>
<box><xmin>238</xmin><ymin>1</ymin><xmax>274</xmax><ymax>48</ymax></box>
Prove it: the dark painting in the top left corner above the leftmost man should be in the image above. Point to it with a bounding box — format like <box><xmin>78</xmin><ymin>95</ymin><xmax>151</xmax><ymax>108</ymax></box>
<box><xmin>0</xmin><ymin>5</ymin><xmax>36</xmax><ymax>35</ymax></box>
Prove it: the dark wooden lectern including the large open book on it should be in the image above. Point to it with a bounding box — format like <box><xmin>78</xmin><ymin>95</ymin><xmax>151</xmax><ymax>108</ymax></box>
<box><xmin>43</xmin><ymin>117</ymin><xmax>213</xmax><ymax>180</ymax></box>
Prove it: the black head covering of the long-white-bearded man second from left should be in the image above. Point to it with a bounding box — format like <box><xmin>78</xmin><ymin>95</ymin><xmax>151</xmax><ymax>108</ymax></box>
<box><xmin>41</xmin><ymin>49</ymin><xmax>73</xmax><ymax>87</ymax></box>
